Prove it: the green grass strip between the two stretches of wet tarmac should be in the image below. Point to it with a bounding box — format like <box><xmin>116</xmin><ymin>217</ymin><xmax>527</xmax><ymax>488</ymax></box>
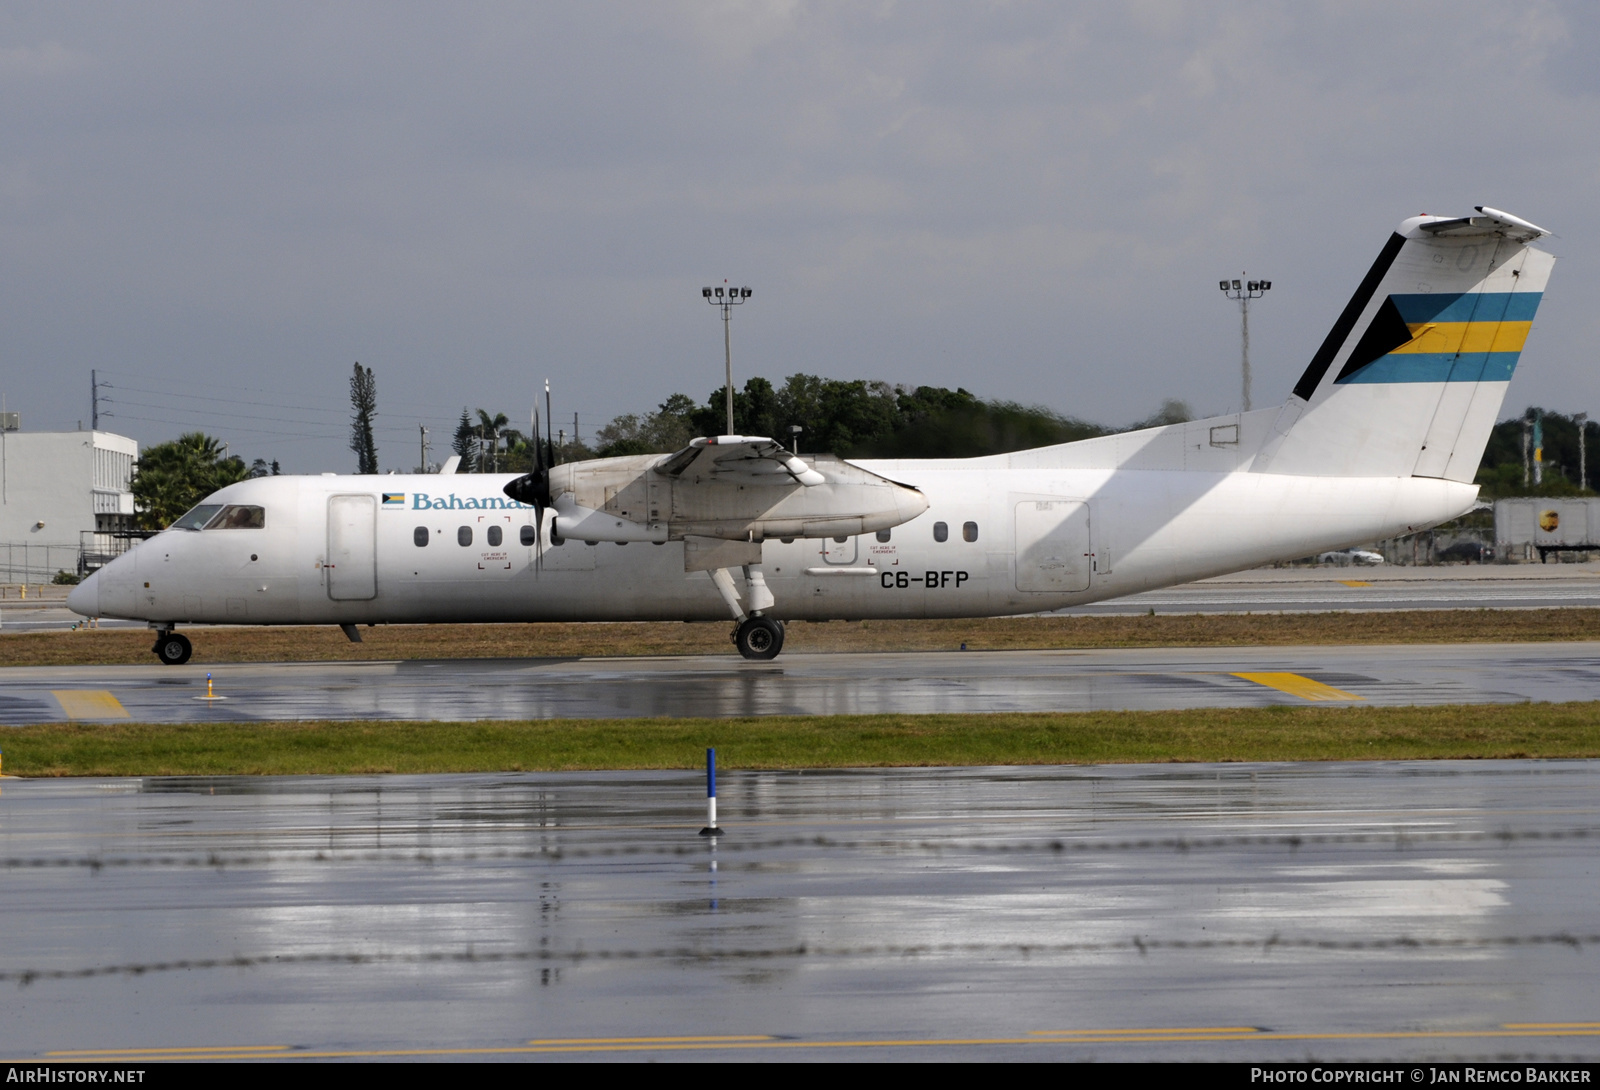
<box><xmin>9</xmin><ymin>701</ymin><xmax>1600</xmax><ymax>776</ymax></box>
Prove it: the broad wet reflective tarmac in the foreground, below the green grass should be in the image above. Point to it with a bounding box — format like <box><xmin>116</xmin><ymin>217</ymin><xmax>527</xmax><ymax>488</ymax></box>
<box><xmin>0</xmin><ymin>760</ymin><xmax>1600</xmax><ymax>1063</ymax></box>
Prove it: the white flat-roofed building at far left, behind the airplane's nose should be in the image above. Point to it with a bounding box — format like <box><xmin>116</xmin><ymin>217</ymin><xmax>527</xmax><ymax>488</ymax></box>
<box><xmin>0</xmin><ymin>413</ymin><xmax>139</xmax><ymax>583</ymax></box>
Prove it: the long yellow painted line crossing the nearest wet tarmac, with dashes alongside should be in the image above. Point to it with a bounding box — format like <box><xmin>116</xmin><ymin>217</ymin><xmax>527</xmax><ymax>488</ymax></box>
<box><xmin>21</xmin><ymin>1023</ymin><xmax>1600</xmax><ymax>1063</ymax></box>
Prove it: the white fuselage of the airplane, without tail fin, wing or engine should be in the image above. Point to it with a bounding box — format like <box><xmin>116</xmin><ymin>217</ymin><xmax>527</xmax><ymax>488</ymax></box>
<box><xmin>69</xmin><ymin>459</ymin><xmax>1477</xmax><ymax>626</ymax></box>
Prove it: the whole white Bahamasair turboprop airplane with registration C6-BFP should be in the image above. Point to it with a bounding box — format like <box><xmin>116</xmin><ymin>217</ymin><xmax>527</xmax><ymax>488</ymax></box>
<box><xmin>67</xmin><ymin>206</ymin><xmax>1554</xmax><ymax>664</ymax></box>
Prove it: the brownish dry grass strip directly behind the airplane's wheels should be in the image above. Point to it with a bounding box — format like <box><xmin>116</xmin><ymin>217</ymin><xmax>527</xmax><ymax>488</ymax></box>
<box><xmin>9</xmin><ymin>608</ymin><xmax>1600</xmax><ymax>666</ymax></box>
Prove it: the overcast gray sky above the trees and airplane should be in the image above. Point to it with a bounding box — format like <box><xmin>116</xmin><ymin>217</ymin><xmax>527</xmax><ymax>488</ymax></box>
<box><xmin>0</xmin><ymin>0</ymin><xmax>1600</xmax><ymax>472</ymax></box>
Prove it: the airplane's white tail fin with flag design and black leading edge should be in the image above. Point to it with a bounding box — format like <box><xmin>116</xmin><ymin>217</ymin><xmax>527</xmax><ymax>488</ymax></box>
<box><xmin>1253</xmin><ymin>206</ymin><xmax>1555</xmax><ymax>483</ymax></box>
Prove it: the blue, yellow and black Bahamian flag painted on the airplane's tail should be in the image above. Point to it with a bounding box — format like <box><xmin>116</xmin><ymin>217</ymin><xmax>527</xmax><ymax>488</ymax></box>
<box><xmin>1334</xmin><ymin>291</ymin><xmax>1542</xmax><ymax>383</ymax></box>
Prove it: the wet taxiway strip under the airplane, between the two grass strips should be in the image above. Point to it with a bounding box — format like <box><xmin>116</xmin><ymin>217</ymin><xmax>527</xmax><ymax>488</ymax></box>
<box><xmin>9</xmin><ymin>643</ymin><xmax>1600</xmax><ymax>725</ymax></box>
